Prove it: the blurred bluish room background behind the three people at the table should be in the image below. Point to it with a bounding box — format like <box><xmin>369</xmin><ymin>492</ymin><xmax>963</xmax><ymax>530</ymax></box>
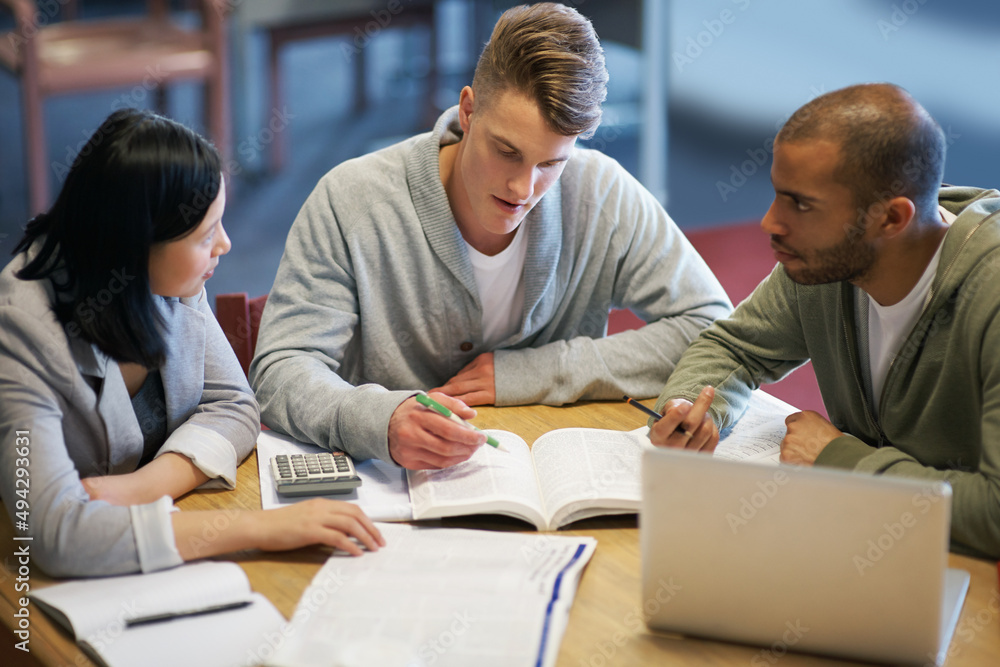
<box><xmin>0</xmin><ymin>0</ymin><xmax>1000</xmax><ymax>306</ymax></box>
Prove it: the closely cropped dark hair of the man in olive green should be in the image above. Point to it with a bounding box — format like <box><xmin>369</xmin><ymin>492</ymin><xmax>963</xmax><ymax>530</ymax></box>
<box><xmin>775</xmin><ymin>83</ymin><xmax>946</xmax><ymax>215</ymax></box>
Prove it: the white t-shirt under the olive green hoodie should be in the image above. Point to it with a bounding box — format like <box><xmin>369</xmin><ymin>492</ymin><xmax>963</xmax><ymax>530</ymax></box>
<box><xmin>868</xmin><ymin>208</ymin><xmax>955</xmax><ymax>414</ymax></box>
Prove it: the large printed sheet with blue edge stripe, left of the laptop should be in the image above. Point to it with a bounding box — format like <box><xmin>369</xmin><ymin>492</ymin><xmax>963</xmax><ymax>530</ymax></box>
<box><xmin>267</xmin><ymin>524</ymin><xmax>596</xmax><ymax>667</ymax></box>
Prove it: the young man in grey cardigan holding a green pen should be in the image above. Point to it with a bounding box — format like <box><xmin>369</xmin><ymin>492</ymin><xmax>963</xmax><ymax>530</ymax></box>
<box><xmin>250</xmin><ymin>3</ymin><xmax>730</xmax><ymax>469</ymax></box>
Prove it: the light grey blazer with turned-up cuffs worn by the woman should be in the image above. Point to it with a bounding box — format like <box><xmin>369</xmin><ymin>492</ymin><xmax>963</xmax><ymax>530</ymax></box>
<box><xmin>0</xmin><ymin>251</ymin><xmax>260</xmax><ymax>576</ymax></box>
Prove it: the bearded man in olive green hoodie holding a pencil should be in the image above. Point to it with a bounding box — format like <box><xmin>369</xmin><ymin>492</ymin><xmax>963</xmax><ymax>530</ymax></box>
<box><xmin>650</xmin><ymin>84</ymin><xmax>1000</xmax><ymax>559</ymax></box>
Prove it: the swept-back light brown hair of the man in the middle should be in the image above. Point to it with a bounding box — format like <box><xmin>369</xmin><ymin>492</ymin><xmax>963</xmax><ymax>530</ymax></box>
<box><xmin>472</xmin><ymin>2</ymin><xmax>608</xmax><ymax>139</ymax></box>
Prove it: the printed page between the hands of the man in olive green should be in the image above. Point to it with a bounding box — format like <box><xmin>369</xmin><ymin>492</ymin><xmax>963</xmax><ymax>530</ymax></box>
<box><xmin>715</xmin><ymin>389</ymin><xmax>798</xmax><ymax>465</ymax></box>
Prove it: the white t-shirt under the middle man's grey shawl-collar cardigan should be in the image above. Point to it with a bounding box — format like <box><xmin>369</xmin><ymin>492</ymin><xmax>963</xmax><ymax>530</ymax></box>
<box><xmin>465</xmin><ymin>224</ymin><xmax>528</xmax><ymax>349</ymax></box>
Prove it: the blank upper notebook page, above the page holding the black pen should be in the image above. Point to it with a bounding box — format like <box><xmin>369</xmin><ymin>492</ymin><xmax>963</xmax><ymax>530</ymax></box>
<box><xmin>31</xmin><ymin>561</ymin><xmax>251</xmax><ymax>643</ymax></box>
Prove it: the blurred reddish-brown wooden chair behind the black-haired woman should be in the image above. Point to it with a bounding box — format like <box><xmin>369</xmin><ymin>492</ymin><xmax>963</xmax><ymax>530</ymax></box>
<box><xmin>0</xmin><ymin>0</ymin><xmax>232</xmax><ymax>215</ymax></box>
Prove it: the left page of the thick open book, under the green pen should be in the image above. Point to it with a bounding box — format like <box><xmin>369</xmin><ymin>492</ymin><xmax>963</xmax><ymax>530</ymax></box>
<box><xmin>406</xmin><ymin>430</ymin><xmax>546</xmax><ymax>528</ymax></box>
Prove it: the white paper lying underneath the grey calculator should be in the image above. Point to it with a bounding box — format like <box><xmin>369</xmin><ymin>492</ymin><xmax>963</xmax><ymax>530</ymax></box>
<box><xmin>257</xmin><ymin>431</ymin><xmax>413</xmax><ymax>521</ymax></box>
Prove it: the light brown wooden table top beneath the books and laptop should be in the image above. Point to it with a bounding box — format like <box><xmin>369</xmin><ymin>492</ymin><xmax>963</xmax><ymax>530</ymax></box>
<box><xmin>0</xmin><ymin>403</ymin><xmax>1000</xmax><ymax>667</ymax></box>
